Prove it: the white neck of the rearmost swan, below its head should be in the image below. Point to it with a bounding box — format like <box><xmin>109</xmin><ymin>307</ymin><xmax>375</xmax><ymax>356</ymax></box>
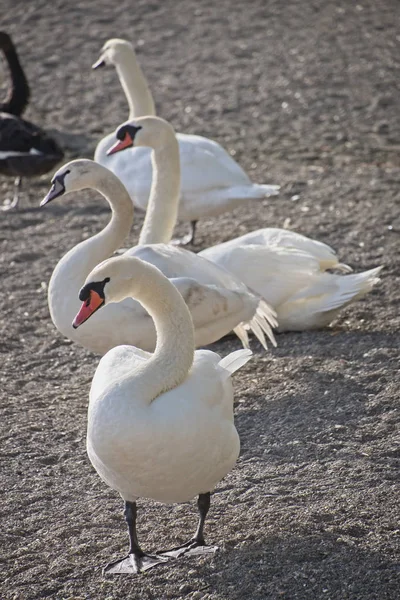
<box><xmin>115</xmin><ymin>48</ymin><xmax>156</xmax><ymax>121</ymax></box>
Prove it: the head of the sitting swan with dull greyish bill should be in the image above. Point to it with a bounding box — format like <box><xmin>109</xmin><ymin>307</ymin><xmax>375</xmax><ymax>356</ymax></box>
<box><xmin>40</xmin><ymin>158</ymin><xmax>110</xmax><ymax>206</ymax></box>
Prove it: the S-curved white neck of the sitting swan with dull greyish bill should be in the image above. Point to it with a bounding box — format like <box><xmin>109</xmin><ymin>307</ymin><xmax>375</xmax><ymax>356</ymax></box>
<box><xmin>48</xmin><ymin>161</ymin><xmax>133</xmax><ymax>329</ymax></box>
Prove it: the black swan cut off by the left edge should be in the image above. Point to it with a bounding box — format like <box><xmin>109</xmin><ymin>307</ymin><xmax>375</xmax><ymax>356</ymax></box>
<box><xmin>0</xmin><ymin>32</ymin><xmax>64</xmax><ymax>210</ymax></box>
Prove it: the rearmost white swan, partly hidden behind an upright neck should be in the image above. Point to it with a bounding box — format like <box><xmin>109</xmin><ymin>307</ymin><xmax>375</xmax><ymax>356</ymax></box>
<box><xmin>93</xmin><ymin>39</ymin><xmax>279</xmax><ymax>243</ymax></box>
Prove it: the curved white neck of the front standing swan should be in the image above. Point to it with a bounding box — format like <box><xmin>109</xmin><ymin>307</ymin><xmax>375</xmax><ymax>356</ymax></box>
<box><xmin>124</xmin><ymin>262</ymin><xmax>195</xmax><ymax>403</ymax></box>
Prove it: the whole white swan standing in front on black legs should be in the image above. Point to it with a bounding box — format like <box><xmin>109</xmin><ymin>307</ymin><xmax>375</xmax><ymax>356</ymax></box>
<box><xmin>74</xmin><ymin>257</ymin><xmax>251</xmax><ymax>573</ymax></box>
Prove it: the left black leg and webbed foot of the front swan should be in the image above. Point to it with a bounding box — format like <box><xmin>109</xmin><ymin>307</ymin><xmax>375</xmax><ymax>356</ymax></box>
<box><xmin>103</xmin><ymin>502</ymin><xmax>168</xmax><ymax>574</ymax></box>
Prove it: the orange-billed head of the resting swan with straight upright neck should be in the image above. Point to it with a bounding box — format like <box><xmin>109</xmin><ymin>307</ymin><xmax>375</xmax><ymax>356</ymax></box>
<box><xmin>107</xmin><ymin>117</ymin><xmax>175</xmax><ymax>155</ymax></box>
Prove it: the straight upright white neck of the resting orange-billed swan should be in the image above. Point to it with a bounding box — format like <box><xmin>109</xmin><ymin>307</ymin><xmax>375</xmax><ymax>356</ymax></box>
<box><xmin>139</xmin><ymin>134</ymin><xmax>181</xmax><ymax>244</ymax></box>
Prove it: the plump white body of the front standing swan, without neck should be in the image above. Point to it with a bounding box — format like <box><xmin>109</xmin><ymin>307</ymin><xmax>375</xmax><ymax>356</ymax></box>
<box><xmin>87</xmin><ymin>346</ymin><xmax>239</xmax><ymax>504</ymax></box>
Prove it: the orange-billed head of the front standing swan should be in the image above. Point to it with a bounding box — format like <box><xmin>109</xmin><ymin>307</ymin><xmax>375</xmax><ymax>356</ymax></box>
<box><xmin>72</xmin><ymin>256</ymin><xmax>152</xmax><ymax>329</ymax></box>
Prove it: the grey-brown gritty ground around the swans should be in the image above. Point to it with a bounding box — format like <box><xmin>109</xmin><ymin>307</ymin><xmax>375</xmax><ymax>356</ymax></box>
<box><xmin>0</xmin><ymin>0</ymin><xmax>400</xmax><ymax>600</ymax></box>
